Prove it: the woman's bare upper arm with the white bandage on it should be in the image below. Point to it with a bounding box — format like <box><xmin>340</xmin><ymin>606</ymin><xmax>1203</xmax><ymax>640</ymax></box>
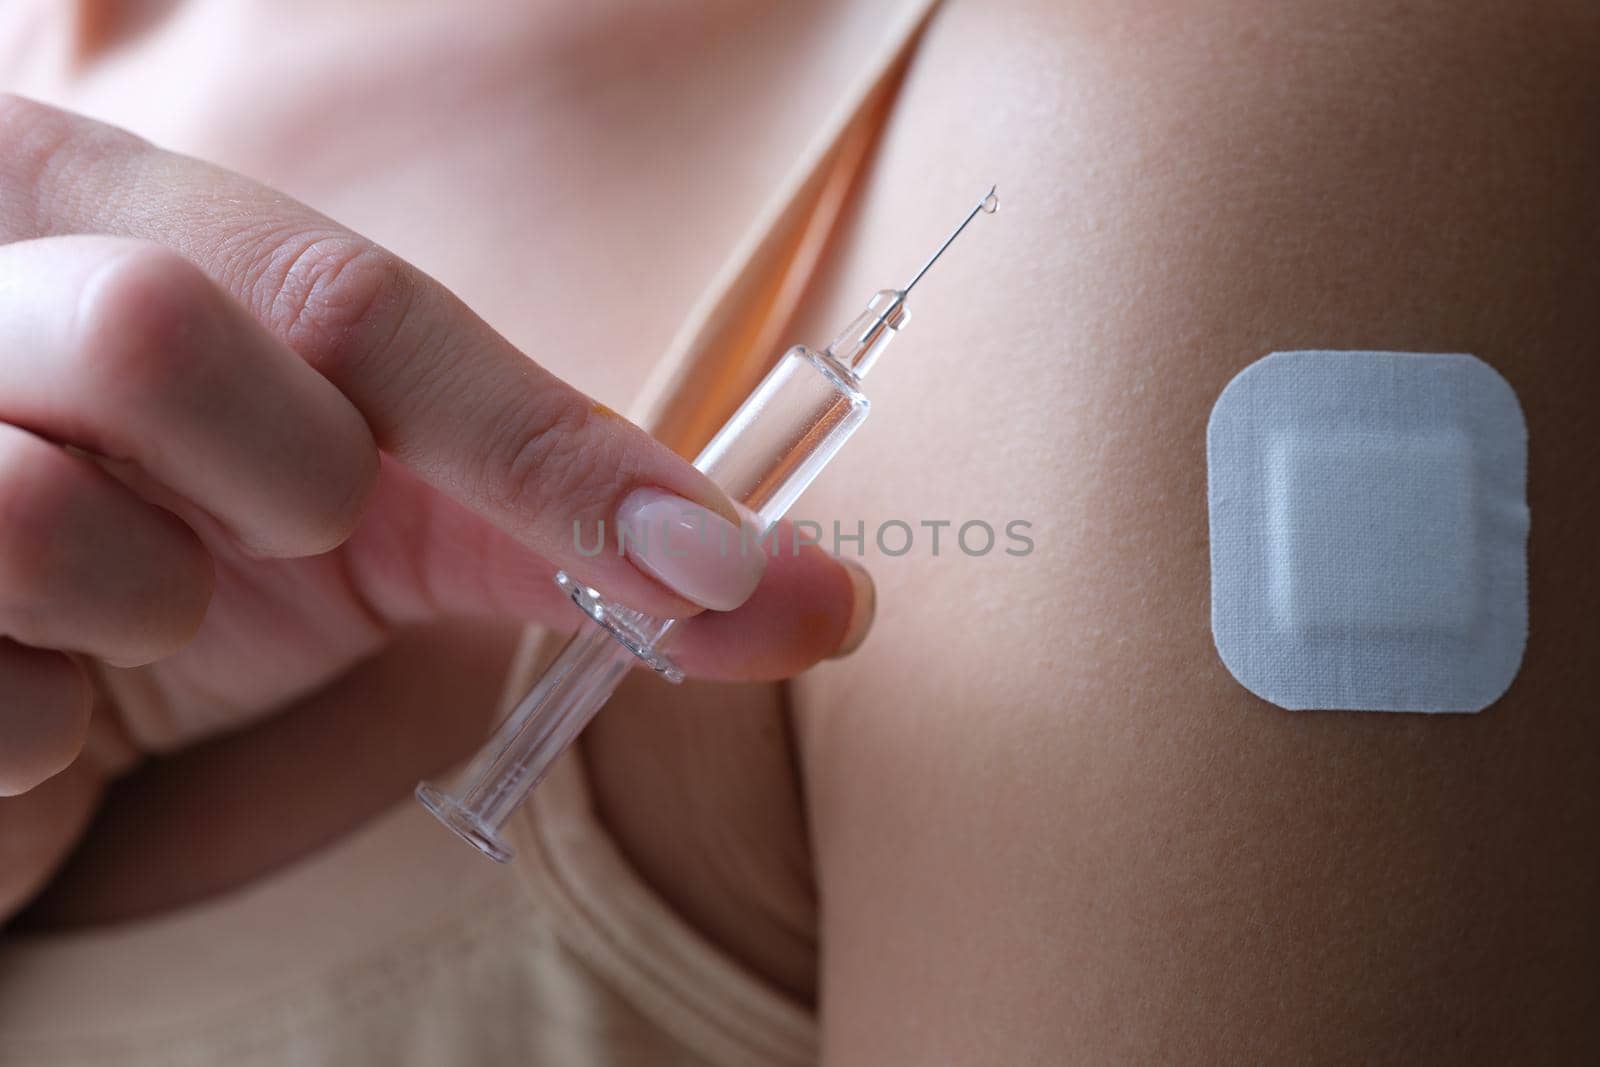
<box><xmin>794</xmin><ymin>0</ymin><xmax>1600</xmax><ymax>1067</ymax></box>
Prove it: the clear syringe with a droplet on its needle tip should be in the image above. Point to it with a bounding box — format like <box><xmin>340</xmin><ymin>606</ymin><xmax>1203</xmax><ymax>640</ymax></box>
<box><xmin>416</xmin><ymin>189</ymin><xmax>998</xmax><ymax>862</ymax></box>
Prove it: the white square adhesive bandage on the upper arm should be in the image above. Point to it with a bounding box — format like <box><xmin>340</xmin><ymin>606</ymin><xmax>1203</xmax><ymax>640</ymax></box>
<box><xmin>1206</xmin><ymin>352</ymin><xmax>1528</xmax><ymax>712</ymax></box>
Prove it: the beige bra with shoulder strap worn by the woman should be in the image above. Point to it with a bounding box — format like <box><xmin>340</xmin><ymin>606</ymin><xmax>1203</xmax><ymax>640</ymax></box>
<box><xmin>0</xmin><ymin>0</ymin><xmax>938</xmax><ymax>1067</ymax></box>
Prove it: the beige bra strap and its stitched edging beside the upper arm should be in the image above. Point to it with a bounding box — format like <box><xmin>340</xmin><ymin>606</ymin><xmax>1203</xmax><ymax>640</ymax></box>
<box><xmin>502</xmin><ymin>0</ymin><xmax>938</xmax><ymax>1067</ymax></box>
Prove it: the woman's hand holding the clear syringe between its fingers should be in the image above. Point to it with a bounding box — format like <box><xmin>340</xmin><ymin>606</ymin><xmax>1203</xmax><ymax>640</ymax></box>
<box><xmin>0</xmin><ymin>98</ymin><xmax>870</xmax><ymax>915</ymax></box>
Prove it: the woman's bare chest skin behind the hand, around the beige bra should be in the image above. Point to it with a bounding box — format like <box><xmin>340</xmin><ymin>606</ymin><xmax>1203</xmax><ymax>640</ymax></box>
<box><xmin>0</xmin><ymin>0</ymin><xmax>877</xmax><ymax>993</ymax></box>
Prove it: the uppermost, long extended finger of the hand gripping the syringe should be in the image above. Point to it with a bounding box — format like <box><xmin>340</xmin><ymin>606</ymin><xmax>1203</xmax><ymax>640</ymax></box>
<box><xmin>0</xmin><ymin>96</ymin><xmax>760</xmax><ymax>617</ymax></box>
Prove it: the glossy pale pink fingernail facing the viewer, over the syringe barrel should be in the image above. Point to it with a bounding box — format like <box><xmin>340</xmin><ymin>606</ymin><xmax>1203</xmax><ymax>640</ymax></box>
<box><xmin>616</xmin><ymin>490</ymin><xmax>766</xmax><ymax>611</ymax></box>
